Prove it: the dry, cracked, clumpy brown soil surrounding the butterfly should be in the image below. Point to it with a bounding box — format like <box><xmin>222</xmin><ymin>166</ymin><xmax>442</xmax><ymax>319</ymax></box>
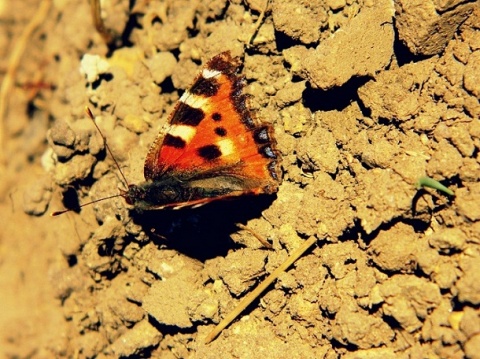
<box><xmin>0</xmin><ymin>0</ymin><xmax>480</xmax><ymax>358</ymax></box>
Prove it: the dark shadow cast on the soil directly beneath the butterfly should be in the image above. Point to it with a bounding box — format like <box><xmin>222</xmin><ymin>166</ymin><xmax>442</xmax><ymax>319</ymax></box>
<box><xmin>127</xmin><ymin>195</ymin><xmax>275</xmax><ymax>261</ymax></box>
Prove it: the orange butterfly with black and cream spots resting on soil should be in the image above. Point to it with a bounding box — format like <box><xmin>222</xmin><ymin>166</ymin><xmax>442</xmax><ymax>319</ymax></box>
<box><xmin>55</xmin><ymin>52</ymin><xmax>281</xmax><ymax>215</ymax></box>
